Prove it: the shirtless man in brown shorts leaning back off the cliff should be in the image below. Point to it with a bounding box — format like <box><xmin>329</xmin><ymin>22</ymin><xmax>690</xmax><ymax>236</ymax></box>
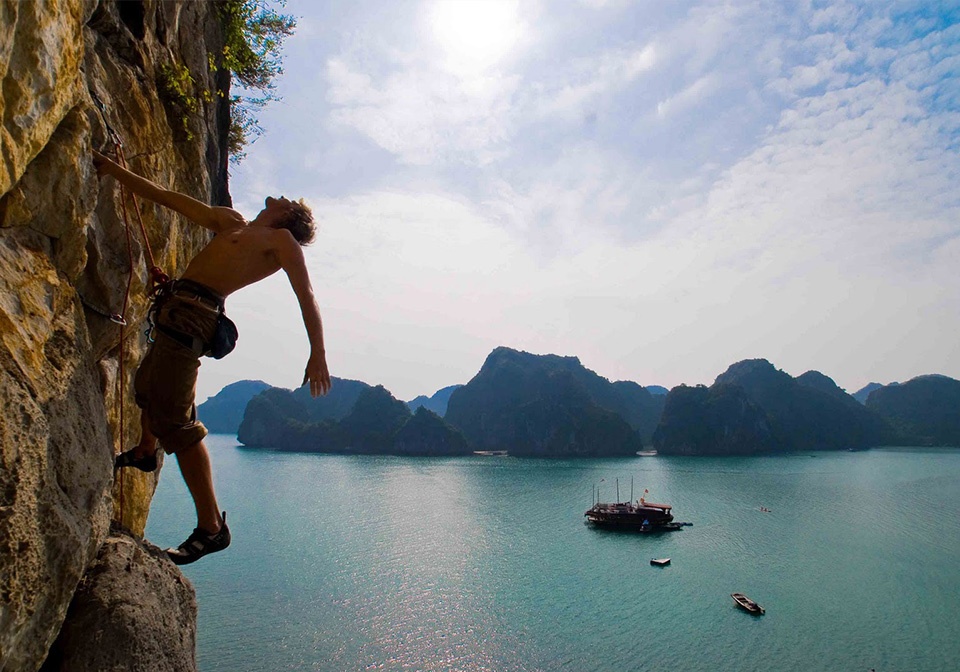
<box><xmin>93</xmin><ymin>152</ymin><xmax>330</xmax><ymax>565</ymax></box>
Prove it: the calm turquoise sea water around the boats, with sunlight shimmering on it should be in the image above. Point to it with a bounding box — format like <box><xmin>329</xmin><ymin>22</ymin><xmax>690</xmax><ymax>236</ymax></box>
<box><xmin>147</xmin><ymin>436</ymin><xmax>960</xmax><ymax>672</ymax></box>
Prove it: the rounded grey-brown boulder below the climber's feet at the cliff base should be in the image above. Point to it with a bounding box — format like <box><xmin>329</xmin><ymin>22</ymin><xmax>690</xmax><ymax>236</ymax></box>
<box><xmin>43</xmin><ymin>528</ymin><xmax>197</xmax><ymax>672</ymax></box>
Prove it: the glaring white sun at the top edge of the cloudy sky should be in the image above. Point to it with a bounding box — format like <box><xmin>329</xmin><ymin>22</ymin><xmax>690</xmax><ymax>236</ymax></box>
<box><xmin>431</xmin><ymin>0</ymin><xmax>520</xmax><ymax>72</ymax></box>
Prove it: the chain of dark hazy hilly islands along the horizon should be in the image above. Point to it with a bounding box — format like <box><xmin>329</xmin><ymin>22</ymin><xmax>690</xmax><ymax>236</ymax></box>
<box><xmin>199</xmin><ymin>347</ymin><xmax>960</xmax><ymax>458</ymax></box>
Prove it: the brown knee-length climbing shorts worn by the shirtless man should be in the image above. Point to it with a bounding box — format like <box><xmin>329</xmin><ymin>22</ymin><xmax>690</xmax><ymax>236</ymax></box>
<box><xmin>133</xmin><ymin>286</ymin><xmax>222</xmax><ymax>455</ymax></box>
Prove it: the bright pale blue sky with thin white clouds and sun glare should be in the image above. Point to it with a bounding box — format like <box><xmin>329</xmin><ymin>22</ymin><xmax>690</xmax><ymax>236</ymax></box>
<box><xmin>198</xmin><ymin>0</ymin><xmax>960</xmax><ymax>400</ymax></box>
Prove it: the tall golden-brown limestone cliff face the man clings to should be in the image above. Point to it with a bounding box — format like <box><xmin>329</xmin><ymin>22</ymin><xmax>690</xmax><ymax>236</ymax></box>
<box><xmin>0</xmin><ymin>0</ymin><xmax>229</xmax><ymax>670</ymax></box>
